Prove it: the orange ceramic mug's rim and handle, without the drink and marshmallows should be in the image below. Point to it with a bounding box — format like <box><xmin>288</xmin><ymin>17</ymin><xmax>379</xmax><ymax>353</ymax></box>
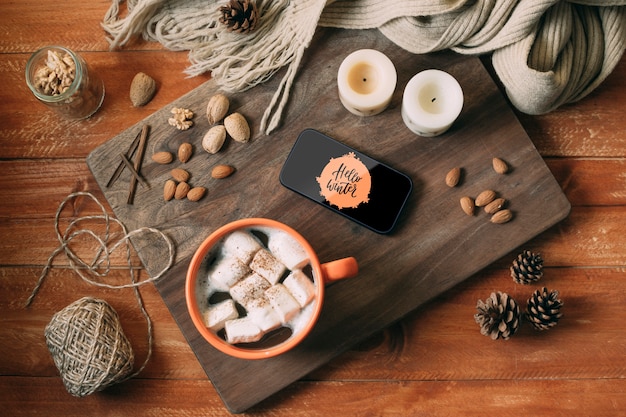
<box><xmin>185</xmin><ymin>218</ymin><xmax>358</xmax><ymax>359</ymax></box>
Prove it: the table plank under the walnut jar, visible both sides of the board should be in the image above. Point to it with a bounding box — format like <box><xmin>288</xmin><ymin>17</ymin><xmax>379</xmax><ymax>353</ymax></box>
<box><xmin>0</xmin><ymin>54</ymin><xmax>626</xmax><ymax>162</ymax></box>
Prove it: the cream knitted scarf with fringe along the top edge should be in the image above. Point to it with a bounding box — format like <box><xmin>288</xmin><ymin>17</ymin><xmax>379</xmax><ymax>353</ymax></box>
<box><xmin>103</xmin><ymin>0</ymin><xmax>626</xmax><ymax>134</ymax></box>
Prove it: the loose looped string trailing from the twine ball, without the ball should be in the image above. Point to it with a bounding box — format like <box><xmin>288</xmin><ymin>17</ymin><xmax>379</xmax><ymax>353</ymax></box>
<box><xmin>26</xmin><ymin>191</ymin><xmax>174</xmax><ymax>379</ymax></box>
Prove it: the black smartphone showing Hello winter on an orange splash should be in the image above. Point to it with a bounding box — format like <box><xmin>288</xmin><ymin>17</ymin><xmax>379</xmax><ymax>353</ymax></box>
<box><xmin>280</xmin><ymin>129</ymin><xmax>413</xmax><ymax>234</ymax></box>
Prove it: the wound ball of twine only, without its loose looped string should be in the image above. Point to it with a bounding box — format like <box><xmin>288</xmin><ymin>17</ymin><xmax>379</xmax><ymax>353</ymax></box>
<box><xmin>45</xmin><ymin>297</ymin><xmax>134</xmax><ymax>397</ymax></box>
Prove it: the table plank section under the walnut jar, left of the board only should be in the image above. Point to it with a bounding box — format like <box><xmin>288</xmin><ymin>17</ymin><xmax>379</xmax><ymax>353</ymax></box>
<box><xmin>0</xmin><ymin>50</ymin><xmax>209</xmax><ymax>159</ymax></box>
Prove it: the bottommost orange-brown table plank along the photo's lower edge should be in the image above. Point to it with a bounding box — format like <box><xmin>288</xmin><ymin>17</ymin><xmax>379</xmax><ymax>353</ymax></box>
<box><xmin>0</xmin><ymin>378</ymin><xmax>626</xmax><ymax>417</ymax></box>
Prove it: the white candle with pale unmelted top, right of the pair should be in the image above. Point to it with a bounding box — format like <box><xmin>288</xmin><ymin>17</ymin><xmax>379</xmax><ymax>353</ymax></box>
<box><xmin>402</xmin><ymin>70</ymin><xmax>463</xmax><ymax>137</ymax></box>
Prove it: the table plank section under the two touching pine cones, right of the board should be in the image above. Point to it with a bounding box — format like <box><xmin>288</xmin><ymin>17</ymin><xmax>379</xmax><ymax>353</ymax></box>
<box><xmin>309</xmin><ymin>266</ymin><xmax>626</xmax><ymax>381</ymax></box>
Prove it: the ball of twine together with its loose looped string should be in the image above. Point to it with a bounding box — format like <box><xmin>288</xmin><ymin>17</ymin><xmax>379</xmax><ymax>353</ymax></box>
<box><xmin>26</xmin><ymin>192</ymin><xmax>174</xmax><ymax>397</ymax></box>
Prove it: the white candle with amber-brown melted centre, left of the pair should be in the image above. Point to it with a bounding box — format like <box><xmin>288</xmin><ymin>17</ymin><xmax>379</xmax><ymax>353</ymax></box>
<box><xmin>337</xmin><ymin>49</ymin><xmax>398</xmax><ymax>116</ymax></box>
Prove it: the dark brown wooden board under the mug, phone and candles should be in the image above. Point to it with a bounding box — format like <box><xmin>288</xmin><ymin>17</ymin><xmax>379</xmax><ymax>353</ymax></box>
<box><xmin>87</xmin><ymin>29</ymin><xmax>570</xmax><ymax>413</ymax></box>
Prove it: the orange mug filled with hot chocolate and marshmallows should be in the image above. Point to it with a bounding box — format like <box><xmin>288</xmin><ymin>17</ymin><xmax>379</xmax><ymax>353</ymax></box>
<box><xmin>185</xmin><ymin>218</ymin><xmax>358</xmax><ymax>359</ymax></box>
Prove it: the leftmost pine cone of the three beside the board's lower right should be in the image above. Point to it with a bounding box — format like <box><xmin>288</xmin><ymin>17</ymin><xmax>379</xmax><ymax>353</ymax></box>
<box><xmin>474</xmin><ymin>291</ymin><xmax>520</xmax><ymax>340</ymax></box>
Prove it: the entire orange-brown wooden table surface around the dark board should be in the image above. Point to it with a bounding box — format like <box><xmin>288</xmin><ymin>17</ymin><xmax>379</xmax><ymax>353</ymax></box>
<box><xmin>0</xmin><ymin>0</ymin><xmax>626</xmax><ymax>417</ymax></box>
